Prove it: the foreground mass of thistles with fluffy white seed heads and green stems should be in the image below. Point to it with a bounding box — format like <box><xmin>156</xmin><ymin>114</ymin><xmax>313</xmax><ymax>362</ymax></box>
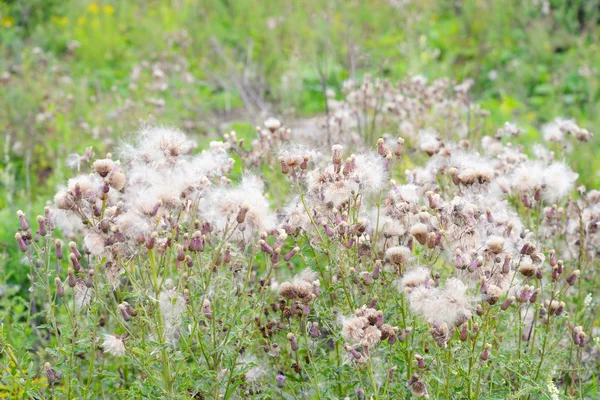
<box><xmin>0</xmin><ymin>78</ymin><xmax>600</xmax><ymax>399</ymax></box>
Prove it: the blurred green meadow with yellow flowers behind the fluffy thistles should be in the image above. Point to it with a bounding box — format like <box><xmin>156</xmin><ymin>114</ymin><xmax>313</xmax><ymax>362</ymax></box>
<box><xmin>0</xmin><ymin>0</ymin><xmax>600</xmax><ymax>283</ymax></box>
